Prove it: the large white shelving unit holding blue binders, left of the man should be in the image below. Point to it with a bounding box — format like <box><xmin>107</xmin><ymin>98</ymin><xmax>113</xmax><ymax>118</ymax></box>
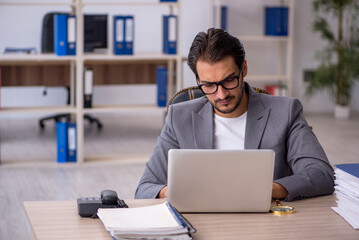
<box><xmin>0</xmin><ymin>0</ymin><xmax>184</xmax><ymax>164</ymax></box>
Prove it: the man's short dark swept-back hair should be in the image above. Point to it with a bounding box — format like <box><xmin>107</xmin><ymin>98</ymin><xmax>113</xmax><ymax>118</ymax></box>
<box><xmin>187</xmin><ymin>28</ymin><xmax>246</xmax><ymax>78</ymax></box>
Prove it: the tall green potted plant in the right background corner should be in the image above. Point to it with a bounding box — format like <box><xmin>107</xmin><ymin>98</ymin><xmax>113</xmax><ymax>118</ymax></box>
<box><xmin>306</xmin><ymin>0</ymin><xmax>359</xmax><ymax>118</ymax></box>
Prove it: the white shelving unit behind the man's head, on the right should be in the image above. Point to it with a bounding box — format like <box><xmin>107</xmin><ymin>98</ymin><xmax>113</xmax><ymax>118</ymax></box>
<box><xmin>210</xmin><ymin>0</ymin><xmax>294</xmax><ymax>96</ymax></box>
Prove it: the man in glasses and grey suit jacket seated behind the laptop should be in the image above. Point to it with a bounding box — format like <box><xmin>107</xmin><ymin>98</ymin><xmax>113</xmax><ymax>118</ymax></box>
<box><xmin>136</xmin><ymin>28</ymin><xmax>334</xmax><ymax>201</ymax></box>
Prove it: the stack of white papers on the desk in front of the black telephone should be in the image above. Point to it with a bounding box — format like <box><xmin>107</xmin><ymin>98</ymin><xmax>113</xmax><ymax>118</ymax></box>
<box><xmin>97</xmin><ymin>202</ymin><xmax>192</xmax><ymax>239</ymax></box>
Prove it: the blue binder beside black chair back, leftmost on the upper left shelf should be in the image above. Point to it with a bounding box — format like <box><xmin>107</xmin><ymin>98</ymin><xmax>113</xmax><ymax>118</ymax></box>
<box><xmin>54</xmin><ymin>14</ymin><xmax>67</xmax><ymax>56</ymax></box>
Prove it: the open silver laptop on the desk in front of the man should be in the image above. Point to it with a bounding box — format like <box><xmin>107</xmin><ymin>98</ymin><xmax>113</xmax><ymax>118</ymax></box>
<box><xmin>167</xmin><ymin>149</ymin><xmax>275</xmax><ymax>212</ymax></box>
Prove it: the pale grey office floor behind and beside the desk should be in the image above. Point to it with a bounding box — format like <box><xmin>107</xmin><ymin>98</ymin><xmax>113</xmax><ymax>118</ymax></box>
<box><xmin>0</xmin><ymin>112</ymin><xmax>359</xmax><ymax>240</ymax></box>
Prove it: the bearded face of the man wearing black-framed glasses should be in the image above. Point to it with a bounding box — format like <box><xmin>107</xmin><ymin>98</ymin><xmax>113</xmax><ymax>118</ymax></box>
<box><xmin>196</xmin><ymin>56</ymin><xmax>247</xmax><ymax>118</ymax></box>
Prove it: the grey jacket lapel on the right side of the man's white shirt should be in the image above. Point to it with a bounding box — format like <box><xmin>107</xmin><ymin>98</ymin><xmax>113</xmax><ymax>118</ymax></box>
<box><xmin>244</xmin><ymin>84</ymin><xmax>270</xmax><ymax>149</ymax></box>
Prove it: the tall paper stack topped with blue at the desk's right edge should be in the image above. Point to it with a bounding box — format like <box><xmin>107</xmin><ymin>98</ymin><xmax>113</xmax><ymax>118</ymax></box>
<box><xmin>332</xmin><ymin>163</ymin><xmax>359</xmax><ymax>229</ymax></box>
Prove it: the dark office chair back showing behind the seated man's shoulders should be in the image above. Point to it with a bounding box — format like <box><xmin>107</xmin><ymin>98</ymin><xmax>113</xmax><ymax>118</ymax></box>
<box><xmin>167</xmin><ymin>86</ymin><xmax>270</xmax><ymax>112</ymax></box>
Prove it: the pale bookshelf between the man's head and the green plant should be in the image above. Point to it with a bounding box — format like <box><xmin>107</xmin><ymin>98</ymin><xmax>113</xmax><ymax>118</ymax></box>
<box><xmin>210</xmin><ymin>0</ymin><xmax>294</xmax><ymax>96</ymax></box>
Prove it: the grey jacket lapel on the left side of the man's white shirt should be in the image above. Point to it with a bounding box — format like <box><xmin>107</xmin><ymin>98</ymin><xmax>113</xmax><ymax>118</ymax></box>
<box><xmin>192</xmin><ymin>100</ymin><xmax>214</xmax><ymax>149</ymax></box>
